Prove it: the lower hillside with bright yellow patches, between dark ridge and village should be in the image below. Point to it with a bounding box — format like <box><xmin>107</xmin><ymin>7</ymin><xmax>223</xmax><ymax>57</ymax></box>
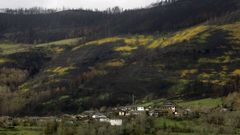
<box><xmin>0</xmin><ymin>12</ymin><xmax>240</xmax><ymax>115</ymax></box>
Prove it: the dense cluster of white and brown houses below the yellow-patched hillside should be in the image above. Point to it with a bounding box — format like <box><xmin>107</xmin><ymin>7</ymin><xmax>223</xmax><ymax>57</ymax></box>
<box><xmin>62</xmin><ymin>102</ymin><xmax>184</xmax><ymax>126</ymax></box>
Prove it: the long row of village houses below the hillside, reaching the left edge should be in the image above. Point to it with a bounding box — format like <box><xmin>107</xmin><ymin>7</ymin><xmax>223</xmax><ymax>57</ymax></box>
<box><xmin>0</xmin><ymin>102</ymin><xmax>191</xmax><ymax>126</ymax></box>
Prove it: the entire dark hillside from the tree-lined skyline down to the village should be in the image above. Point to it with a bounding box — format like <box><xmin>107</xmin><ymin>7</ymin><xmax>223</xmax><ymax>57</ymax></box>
<box><xmin>0</xmin><ymin>0</ymin><xmax>240</xmax><ymax>115</ymax></box>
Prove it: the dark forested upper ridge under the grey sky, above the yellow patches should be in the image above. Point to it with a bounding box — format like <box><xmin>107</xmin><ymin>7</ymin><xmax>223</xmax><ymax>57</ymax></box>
<box><xmin>0</xmin><ymin>0</ymin><xmax>239</xmax><ymax>43</ymax></box>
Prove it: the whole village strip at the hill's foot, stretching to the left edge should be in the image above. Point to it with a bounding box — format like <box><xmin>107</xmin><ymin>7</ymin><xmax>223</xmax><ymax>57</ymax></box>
<box><xmin>0</xmin><ymin>101</ymin><xmax>196</xmax><ymax>127</ymax></box>
